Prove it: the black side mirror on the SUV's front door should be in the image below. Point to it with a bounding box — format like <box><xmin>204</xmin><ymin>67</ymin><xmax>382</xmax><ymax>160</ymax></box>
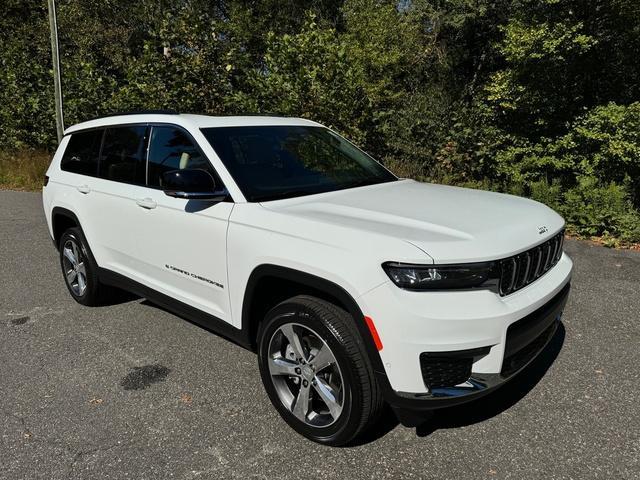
<box><xmin>162</xmin><ymin>169</ymin><xmax>229</xmax><ymax>202</ymax></box>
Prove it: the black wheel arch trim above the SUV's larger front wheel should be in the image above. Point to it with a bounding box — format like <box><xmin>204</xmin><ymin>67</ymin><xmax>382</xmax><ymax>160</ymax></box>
<box><xmin>242</xmin><ymin>264</ymin><xmax>384</xmax><ymax>373</ymax></box>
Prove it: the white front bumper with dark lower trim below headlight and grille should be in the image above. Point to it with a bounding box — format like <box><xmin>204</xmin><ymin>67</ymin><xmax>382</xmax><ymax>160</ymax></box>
<box><xmin>364</xmin><ymin>255</ymin><xmax>572</xmax><ymax>418</ymax></box>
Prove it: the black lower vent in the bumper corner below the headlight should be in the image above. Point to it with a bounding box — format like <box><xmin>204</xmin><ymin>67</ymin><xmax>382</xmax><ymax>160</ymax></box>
<box><xmin>420</xmin><ymin>347</ymin><xmax>490</xmax><ymax>390</ymax></box>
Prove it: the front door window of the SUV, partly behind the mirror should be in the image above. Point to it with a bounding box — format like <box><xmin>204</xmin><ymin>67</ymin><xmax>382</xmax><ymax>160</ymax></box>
<box><xmin>148</xmin><ymin>127</ymin><xmax>212</xmax><ymax>187</ymax></box>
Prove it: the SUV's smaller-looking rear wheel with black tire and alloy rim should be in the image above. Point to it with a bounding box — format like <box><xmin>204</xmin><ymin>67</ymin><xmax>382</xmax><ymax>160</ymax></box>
<box><xmin>58</xmin><ymin>227</ymin><xmax>107</xmax><ymax>307</ymax></box>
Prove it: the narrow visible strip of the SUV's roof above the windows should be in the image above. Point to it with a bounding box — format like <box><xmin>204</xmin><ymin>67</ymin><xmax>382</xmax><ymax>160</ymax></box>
<box><xmin>65</xmin><ymin>113</ymin><xmax>320</xmax><ymax>135</ymax></box>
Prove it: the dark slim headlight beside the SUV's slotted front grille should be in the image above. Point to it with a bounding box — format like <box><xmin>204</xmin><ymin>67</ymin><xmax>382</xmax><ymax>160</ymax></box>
<box><xmin>382</xmin><ymin>262</ymin><xmax>500</xmax><ymax>292</ymax></box>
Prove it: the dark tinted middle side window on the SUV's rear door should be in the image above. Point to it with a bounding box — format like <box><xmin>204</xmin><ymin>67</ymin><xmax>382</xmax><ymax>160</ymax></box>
<box><xmin>99</xmin><ymin>126</ymin><xmax>147</xmax><ymax>185</ymax></box>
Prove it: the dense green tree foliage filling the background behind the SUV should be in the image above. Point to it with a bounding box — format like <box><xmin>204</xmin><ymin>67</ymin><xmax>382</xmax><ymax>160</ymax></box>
<box><xmin>0</xmin><ymin>0</ymin><xmax>640</xmax><ymax>242</ymax></box>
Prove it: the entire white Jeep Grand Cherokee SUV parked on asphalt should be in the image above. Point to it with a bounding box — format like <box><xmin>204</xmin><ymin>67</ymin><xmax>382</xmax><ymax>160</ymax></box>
<box><xmin>43</xmin><ymin>112</ymin><xmax>572</xmax><ymax>445</ymax></box>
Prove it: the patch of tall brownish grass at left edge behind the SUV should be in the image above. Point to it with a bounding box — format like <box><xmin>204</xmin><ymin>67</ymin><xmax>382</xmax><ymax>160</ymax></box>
<box><xmin>0</xmin><ymin>149</ymin><xmax>51</xmax><ymax>191</ymax></box>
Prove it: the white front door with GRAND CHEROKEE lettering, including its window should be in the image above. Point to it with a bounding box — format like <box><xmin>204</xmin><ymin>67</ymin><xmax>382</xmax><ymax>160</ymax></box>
<box><xmin>130</xmin><ymin>125</ymin><xmax>233</xmax><ymax>322</ymax></box>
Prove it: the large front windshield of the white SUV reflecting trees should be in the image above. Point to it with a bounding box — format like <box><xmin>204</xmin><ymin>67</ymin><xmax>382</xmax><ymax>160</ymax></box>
<box><xmin>202</xmin><ymin>125</ymin><xmax>397</xmax><ymax>202</ymax></box>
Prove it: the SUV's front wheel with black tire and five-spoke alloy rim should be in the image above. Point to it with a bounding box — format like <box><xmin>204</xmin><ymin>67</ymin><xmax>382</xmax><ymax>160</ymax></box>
<box><xmin>258</xmin><ymin>295</ymin><xmax>383</xmax><ymax>446</ymax></box>
